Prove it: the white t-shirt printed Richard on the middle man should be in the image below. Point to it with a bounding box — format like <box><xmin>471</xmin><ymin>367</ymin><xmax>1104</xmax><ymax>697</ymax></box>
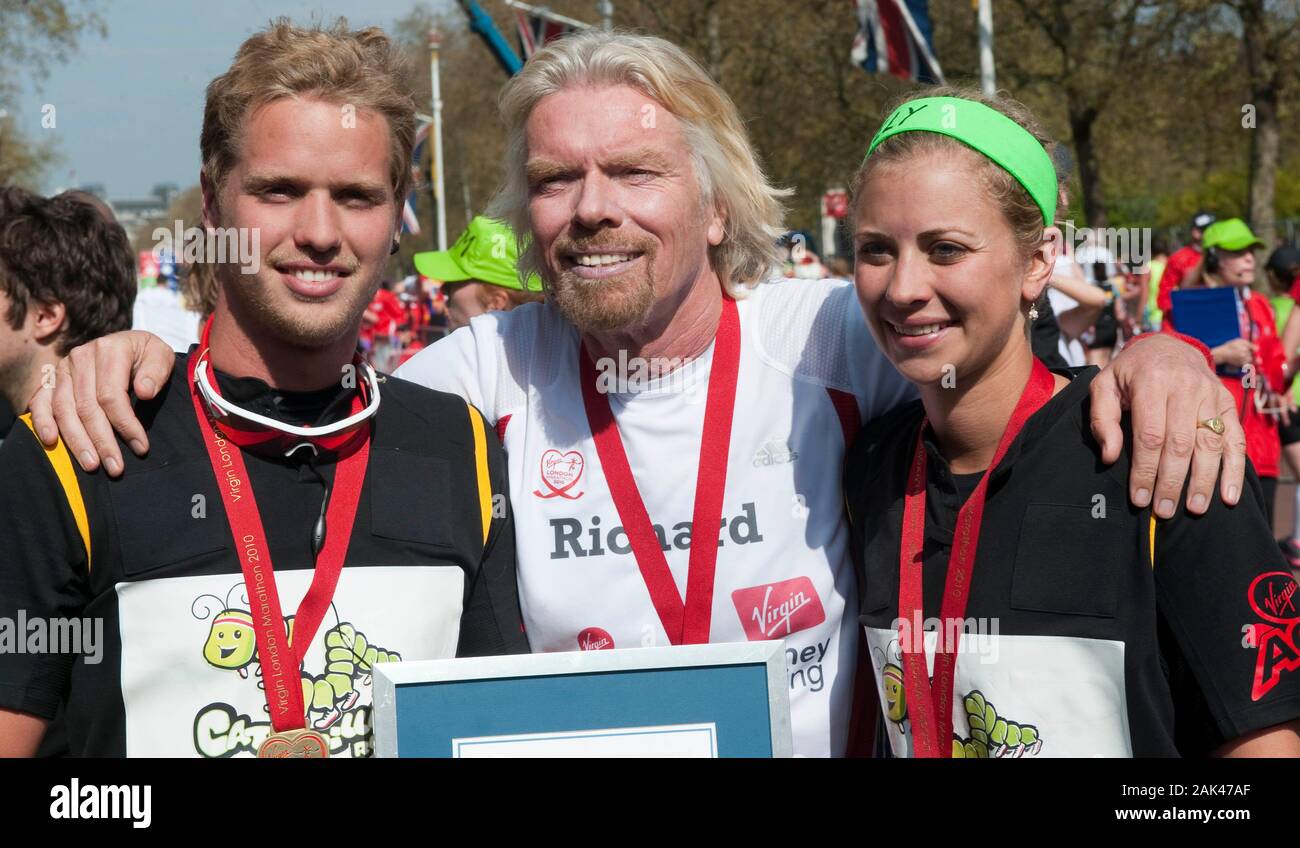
<box><xmin>397</xmin><ymin>278</ymin><xmax>915</xmax><ymax>757</ymax></box>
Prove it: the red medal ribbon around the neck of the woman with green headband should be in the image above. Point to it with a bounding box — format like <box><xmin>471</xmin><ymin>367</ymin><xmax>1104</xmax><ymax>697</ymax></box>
<box><xmin>898</xmin><ymin>358</ymin><xmax>1056</xmax><ymax>757</ymax></box>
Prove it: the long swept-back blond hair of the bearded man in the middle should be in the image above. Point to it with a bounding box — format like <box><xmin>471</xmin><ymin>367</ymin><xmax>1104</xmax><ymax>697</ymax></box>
<box><xmin>489</xmin><ymin>30</ymin><xmax>790</xmax><ymax>293</ymax></box>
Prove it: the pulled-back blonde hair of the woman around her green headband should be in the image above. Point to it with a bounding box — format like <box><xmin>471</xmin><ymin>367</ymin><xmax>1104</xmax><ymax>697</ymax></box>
<box><xmin>849</xmin><ymin>86</ymin><xmax>1070</xmax><ymax>259</ymax></box>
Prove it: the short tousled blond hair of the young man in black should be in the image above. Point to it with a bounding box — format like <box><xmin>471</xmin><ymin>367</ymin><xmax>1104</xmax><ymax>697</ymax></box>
<box><xmin>199</xmin><ymin>18</ymin><xmax>415</xmax><ymax>203</ymax></box>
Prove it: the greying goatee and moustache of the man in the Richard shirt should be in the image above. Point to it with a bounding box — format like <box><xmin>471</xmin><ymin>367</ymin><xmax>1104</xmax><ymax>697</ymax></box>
<box><xmin>547</xmin><ymin>239</ymin><xmax>655</xmax><ymax>333</ymax></box>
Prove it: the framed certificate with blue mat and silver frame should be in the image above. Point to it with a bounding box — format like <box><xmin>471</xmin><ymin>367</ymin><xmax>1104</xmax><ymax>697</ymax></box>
<box><xmin>373</xmin><ymin>641</ymin><xmax>792</xmax><ymax>757</ymax></box>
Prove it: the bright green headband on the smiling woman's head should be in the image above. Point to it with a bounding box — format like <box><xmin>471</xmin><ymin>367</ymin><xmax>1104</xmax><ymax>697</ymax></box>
<box><xmin>867</xmin><ymin>98</ymin><xmax>1057</xmax><ymax>226</ymax></box>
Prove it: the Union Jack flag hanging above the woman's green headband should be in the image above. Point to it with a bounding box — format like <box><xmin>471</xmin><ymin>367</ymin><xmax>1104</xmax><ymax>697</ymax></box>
<box><xmin>852</xmin><ymin>0</ymin><xmax>944</xmax><ymax>85</ymax></box>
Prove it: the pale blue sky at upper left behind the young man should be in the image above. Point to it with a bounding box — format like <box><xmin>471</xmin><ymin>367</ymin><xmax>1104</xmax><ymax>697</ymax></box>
<box><xmin>14</xmin><ymin>0</ymin><xmax>450</xmax><ymax>199</ymax></box>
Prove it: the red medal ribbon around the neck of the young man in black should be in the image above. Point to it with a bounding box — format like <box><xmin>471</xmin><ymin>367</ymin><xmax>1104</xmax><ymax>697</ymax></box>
<box><xmin>189</xmin><ymin>328</ymin><xmax>371</xmax><ymax>732</ymax></box>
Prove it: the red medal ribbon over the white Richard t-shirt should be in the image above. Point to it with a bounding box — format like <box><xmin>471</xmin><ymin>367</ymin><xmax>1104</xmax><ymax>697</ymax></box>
<box><xmin>579</xmin><ymin>295</ymin><xmax>740</xmax><ymax>645</ymax></box>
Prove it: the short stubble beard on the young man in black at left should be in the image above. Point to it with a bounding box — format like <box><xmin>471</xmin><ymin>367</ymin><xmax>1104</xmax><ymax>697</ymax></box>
<box><xmin>222</xmin><ymin>249</ymin><xmax>382</xmax><ymax>350</ymax></box>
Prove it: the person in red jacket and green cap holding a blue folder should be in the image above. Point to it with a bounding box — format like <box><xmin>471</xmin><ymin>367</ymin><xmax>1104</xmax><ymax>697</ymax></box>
<box><xmin>1185</xmin><ymin>219</ymin><xmax>1288</xmax><ymax>522</ymax></box>
